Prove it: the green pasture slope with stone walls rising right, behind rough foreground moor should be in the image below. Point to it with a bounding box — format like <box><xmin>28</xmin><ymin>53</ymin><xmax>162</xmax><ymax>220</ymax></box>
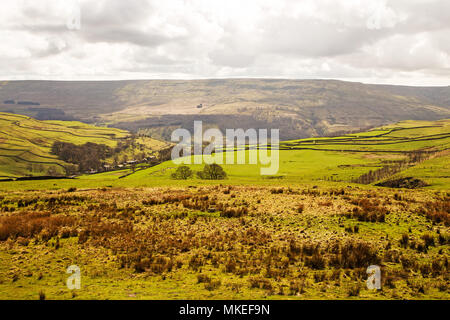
<box><xmin>0</xmin><ymin>120</ymin><xmax>450</xmax><ymax>190</ymax></box>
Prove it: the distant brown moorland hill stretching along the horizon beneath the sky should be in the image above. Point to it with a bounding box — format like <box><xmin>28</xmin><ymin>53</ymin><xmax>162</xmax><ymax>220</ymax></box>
<box><xmin>0</xmin><ymin>79</ymin><xmax>450</xmax><ymax>139</ymax></box>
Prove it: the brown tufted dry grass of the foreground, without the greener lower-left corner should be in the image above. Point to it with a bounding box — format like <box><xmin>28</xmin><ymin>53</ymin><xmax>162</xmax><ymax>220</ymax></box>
<box><xmin>0</xmin><ymin>186</ymin><xmax>449</xmax><ymax>297</ymax></box>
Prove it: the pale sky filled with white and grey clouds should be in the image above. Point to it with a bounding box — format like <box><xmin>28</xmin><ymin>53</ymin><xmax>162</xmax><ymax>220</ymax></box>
<box><xmin>0</xmin><ymin>0</ymin><xmax>450</xmax><ymax>86</ymax></box>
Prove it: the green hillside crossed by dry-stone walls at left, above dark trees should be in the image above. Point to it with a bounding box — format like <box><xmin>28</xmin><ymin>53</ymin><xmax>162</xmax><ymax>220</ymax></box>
<box><xmin>0</xmin><ymin>113</ymin><xmax>171</xmax><ymax>179</ymax></box>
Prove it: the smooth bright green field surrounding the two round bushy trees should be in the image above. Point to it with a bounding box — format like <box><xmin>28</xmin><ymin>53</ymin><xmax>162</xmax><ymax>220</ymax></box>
<box><xmin>0</xmin><ymin>150</ymin><xmax>400</xmax><ymax>190</ymax></box>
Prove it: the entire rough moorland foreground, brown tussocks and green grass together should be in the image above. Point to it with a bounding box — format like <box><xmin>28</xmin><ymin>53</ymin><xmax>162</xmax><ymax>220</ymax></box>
<box><xmin>0</xmin><ymin>186</ymin><xmax>450</xmax><ymax>299</ymax></box>
